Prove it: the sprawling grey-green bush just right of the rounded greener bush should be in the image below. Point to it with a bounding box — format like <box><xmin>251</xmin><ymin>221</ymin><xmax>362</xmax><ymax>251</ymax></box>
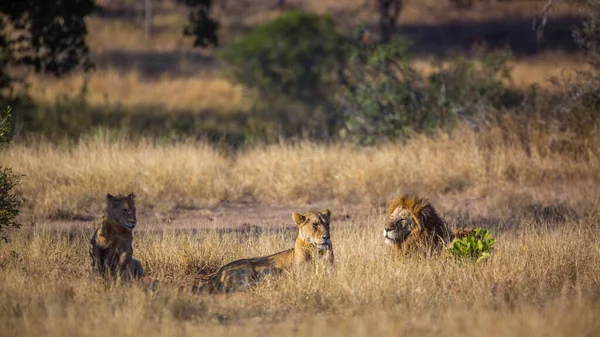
<box><xmin>338</xmin><ymin>36</ymin><xmax>519</xmax><ymax>144</ymax></box>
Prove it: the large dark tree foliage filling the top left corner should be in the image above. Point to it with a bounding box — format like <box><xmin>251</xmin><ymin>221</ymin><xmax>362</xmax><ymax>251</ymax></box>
<box><xmin>0</xmin><ymin>0</ymin><xmax>95</xmax><ymax>76</ymax></box>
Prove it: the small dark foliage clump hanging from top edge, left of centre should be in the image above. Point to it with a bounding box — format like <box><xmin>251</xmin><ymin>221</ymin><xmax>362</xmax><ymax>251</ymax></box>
<box><xmin>183</xmin><ymin>0</ymin><xmax>219</xmax><ymax>47</ymax></box>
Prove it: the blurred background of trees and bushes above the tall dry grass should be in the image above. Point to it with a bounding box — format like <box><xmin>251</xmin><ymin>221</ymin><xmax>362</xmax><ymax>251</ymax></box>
<box><xmin>0</xmin><ymin>0</ymin><xmax>600</xmax><ymax>148</ymax></box>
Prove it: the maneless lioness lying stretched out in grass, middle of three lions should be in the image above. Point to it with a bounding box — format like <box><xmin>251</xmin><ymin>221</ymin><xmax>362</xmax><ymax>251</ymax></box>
<box><xmin>192</xmin><ymin>209</ymin><xmax>334</xmax><ymax>293</ymax></box>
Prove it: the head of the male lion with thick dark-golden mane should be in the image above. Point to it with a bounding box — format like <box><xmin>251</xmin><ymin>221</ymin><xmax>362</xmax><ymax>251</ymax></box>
<box><xmin>383</xmin><ymin>195</ymin><xmax>447</xmax><ymax>251</ymax></box>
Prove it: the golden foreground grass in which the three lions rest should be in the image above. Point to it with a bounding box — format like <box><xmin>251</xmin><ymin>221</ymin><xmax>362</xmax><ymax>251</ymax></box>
<box><xmin>0</xmin><ymin>209</ymin><xmax>600</xmax><ymax>336</ymax></box>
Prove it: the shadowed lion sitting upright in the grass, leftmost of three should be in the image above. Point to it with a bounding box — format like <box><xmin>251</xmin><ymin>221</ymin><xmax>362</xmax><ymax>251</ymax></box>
<box><xmin>90</xmin><ymin>192</ymin><xmax>144</xmax><ymax>279</ymax></box>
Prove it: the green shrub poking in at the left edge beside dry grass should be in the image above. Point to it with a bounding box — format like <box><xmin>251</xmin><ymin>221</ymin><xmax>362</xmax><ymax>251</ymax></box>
<box><xmin>0</xmin><ymin>107</ymin><xmax>25</xmax><ymax>241</ymax></box>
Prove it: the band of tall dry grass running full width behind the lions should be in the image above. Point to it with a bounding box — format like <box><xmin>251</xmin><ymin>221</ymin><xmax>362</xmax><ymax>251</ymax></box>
<box><xmin>0</xmin><ymin>127</ymin><xmax>600</xmax><ymax>217</ymax></box>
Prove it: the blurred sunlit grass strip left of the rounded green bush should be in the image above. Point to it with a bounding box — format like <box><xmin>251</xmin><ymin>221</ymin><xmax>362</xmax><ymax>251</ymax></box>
<box><xmin>30</xmin><ymin>70</ymin><xmax>243</xmax><ymax>114</ymax></box>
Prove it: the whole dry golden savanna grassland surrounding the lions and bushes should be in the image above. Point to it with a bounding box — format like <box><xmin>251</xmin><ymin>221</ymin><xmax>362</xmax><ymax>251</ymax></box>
<box><xmin>0</xmin><ymin>0</ymin><xmax>600</xmax><ymax>337</ymax></box>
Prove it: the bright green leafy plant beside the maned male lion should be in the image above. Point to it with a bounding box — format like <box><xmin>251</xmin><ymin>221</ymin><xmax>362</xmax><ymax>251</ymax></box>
<box><xmin>448</xmin><ymin>228</ymin><xmax>496</xmax><ymax>262</ymax></box>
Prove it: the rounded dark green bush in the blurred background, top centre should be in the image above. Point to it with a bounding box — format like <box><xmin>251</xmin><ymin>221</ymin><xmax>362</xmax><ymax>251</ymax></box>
<box><xmin>219</xmin><ymin>11</ymin><xmax>343</xmax><ymax>136</ymax></box>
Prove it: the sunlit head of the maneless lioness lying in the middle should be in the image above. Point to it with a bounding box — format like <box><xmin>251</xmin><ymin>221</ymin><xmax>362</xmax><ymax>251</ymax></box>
<box><xmin>292</xmin><ymin>209</ymin><xmax>332</xmax><ymax>250</ymax></box>
